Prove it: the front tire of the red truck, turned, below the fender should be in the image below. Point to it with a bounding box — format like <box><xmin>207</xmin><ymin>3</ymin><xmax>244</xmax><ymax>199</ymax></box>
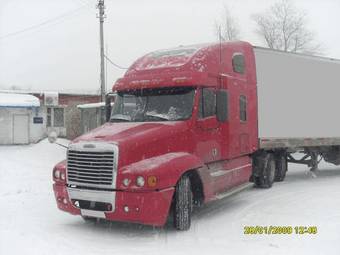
<box><xmin>174</xmin><ymin>175</ymin><xmax>193</xmax><ymax>231</ymax></box>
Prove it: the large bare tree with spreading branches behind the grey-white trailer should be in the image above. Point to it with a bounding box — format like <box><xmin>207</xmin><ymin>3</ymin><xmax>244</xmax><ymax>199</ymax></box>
<box><xmin>253</xmin><ymin>0</ymin><xmax>322</xmax><ymax>55</ymax></box>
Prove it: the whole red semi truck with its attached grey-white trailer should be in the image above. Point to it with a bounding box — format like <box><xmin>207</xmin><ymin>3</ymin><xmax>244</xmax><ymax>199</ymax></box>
<box><xmin>53</xmin><ymin>42</ymin><xmax>340</xmax><ymax>230</ymax></box>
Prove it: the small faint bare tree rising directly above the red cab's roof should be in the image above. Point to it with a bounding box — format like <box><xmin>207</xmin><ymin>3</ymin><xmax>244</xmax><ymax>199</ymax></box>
<box><xmin>215</xmin><ymin>6</ymin><xmax>240</xmax><ymax>41</ymax></box>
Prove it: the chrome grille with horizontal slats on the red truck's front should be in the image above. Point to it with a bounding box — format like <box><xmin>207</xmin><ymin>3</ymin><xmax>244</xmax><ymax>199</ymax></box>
<box><xmin>67</xmin><ymin>150</ymin><xmax>115</xmax><ymax>186</ymax></box>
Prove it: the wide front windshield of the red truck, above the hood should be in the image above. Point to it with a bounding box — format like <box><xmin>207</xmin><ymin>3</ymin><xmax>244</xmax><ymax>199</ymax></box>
<box><xmin>110</xmin><ymin>88</ymin><xmax>195</xmax><ymax>122</ymax></box>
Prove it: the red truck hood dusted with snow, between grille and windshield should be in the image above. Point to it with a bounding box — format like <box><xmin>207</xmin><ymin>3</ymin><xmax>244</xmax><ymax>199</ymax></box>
<box><xmin>72</xmin><ymin>121</ymin><xmax>192</xmax><ymax>167</ymax></box>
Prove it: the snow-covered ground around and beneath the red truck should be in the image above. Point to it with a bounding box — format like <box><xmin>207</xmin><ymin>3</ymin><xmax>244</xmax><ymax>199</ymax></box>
<box><xmin>0</xmin><ymin>140</ymin><xmax>340</xmax><ymax>255</ymax></box>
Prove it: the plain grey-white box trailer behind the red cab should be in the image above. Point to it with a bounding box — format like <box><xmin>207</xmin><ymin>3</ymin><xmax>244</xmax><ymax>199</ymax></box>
<box><xmin>254</xmin><ymin>47</ymin><xmax>340</xmax><ymax>180</ymax></box>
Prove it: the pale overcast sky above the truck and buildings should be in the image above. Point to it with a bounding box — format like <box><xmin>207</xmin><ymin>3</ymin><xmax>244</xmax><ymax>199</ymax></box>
<box><xmin>0</xmin><ymin>0</ymin><xmax>340</xmax><ymax>91</ymax></box>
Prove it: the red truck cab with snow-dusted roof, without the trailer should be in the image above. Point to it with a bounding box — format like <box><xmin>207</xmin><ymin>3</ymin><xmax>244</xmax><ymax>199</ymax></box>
<box><xmin>53</xmin><ymin>42</ymin><xmax>258</xmax><ymax>230</ymax></box>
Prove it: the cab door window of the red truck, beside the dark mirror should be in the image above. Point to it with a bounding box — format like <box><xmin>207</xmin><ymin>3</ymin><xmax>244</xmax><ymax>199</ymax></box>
<box><xmin>198</xmin><ymin>88</ymin><xmax>216</xmax><ymax>119</ymax></box>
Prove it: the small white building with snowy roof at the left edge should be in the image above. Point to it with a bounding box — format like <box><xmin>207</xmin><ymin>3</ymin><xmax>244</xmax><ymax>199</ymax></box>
<box><xmin>0</xmin><ymin>93</ymin><xmax>46</xmax><ymax>144</ymax></box>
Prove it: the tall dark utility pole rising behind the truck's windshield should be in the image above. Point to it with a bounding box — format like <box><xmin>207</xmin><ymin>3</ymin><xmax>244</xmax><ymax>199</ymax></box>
<box><xmin>97</xmin><ymin>0</ymin><xmax>106</xmax><ymax>102</ymax></box>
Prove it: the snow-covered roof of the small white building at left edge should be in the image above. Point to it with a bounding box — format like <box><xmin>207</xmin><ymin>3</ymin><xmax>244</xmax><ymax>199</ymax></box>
<box><xmin>0</xmin><ymin>93</ymin><xmax>40</xmax><ymax>108</ymax></box>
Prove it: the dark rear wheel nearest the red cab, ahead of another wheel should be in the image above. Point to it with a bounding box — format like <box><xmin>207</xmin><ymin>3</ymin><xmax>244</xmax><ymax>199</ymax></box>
<box><xmin>254</xmin><ymin>153</ymin><xmax>275</xmax><ymax>188</ymax></box>
